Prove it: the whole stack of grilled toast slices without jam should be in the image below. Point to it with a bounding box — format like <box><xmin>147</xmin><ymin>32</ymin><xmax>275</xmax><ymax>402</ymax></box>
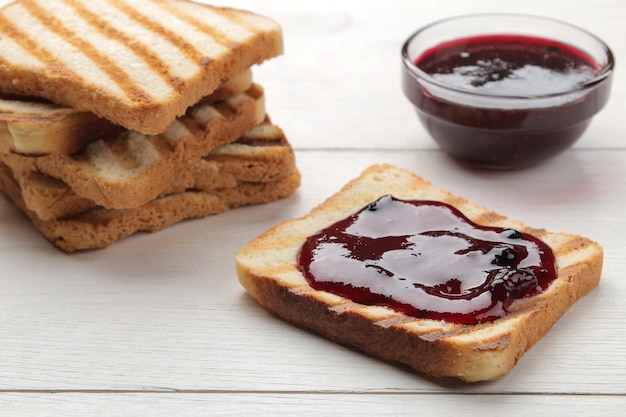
<box><xmin>0</xmin><ymin>0</ymin><xmax>300</xmax><ymax>252</ymax></box>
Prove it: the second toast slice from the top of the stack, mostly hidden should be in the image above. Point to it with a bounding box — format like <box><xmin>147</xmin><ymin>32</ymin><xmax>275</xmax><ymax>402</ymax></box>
<box><xmin>0</xmin><ymin>70</ymin><xmax>252</xmax><ymax>156</ymax></box>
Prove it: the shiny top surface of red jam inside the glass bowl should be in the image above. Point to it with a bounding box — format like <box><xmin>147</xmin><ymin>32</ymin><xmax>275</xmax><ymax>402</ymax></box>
<box><xmin>415</xmin><ymin>35</ymin><xmax>599</xmax><ymax>96</ymax></box>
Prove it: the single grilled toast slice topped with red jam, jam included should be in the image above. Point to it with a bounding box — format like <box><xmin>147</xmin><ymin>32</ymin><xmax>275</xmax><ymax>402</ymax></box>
<box><xmin>236</xmin><ymin>165</ymin><xmax>603</xmax><ymax>381</ymax></box>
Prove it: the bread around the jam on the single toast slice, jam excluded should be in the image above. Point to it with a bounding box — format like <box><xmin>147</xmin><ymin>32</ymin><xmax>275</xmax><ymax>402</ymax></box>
<box><xmin>236</xmin><ymin>165</ymin><xmax>603</xmax><ymax>381</ymax></box>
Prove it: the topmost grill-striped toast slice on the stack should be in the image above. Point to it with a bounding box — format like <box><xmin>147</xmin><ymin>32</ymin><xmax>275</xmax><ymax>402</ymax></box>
<box><xmin>0</xmin><ymin>0</ymin><xmax>283</xmax><ymax>135</ymax></box>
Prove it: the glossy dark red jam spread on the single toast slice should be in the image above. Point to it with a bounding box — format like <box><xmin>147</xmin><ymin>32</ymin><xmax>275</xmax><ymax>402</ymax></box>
<box><xmin>298</xmin><ymin>196</ymin><xmax>556</xmax><ymax>324</ymax></box>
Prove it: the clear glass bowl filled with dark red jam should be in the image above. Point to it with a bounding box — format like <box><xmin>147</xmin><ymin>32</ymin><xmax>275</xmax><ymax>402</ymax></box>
<box><xmin>402</xmin><ymin>14</ymin><xmax>614</xmax><ymax>169</ymax></box>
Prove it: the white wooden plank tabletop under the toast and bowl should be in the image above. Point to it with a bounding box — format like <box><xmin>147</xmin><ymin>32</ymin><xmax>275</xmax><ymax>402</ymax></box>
<box><xmin>0</xmin><ymin>0</ymin><xmax>626</xmax><ymax>417</ymax></box>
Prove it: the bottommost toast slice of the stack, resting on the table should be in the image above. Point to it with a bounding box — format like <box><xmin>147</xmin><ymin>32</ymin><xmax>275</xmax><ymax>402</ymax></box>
<box><xmin>0</xmin><ymin>156</ymin><xmax>300</xmax><ymax>253</ymax></box>
